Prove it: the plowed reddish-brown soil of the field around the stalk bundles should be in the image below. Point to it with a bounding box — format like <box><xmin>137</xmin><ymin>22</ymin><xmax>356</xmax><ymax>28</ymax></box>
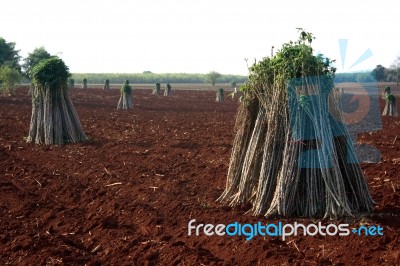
<box><xmin>0</xmin><ymin>85</ymin><xmax>400</xmax><ymax>265</ymax></box>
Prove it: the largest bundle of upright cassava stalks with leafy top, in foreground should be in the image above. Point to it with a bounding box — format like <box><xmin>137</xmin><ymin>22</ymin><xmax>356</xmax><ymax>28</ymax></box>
<box><xmin>218</xmin><ymin>30</ymin><xmax>373</xmax><ymax>218</ymax></box>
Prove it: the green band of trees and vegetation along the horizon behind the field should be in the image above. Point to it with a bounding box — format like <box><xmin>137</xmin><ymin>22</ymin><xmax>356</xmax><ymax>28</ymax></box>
<box><xmin>0</xmin><ymin>34</ymin><xmax>400</xmax><ymax>94</ymax></box>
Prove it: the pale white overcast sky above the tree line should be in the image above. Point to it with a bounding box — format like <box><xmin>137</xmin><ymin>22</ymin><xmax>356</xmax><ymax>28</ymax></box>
<box><xmin>0</xmin><ymin>0</ymin><xmax>400</xmax><ymax>75</ymax></box>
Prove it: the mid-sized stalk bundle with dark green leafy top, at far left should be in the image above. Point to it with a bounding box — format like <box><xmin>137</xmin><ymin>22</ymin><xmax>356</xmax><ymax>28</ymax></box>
<box><xmin>27</xmin><ymin>57</ymin><xmax>88</xmax><ymax>144</ymax></box>
